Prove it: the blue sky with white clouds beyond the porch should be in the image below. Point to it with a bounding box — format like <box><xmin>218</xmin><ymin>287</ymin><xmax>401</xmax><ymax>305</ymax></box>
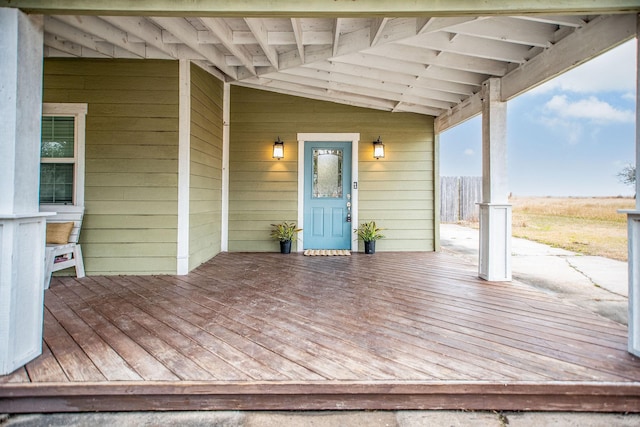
<box><xmin>440</xmin><ymin>39</ymin><xmax>636</xmax><ymax>196</ymax></box>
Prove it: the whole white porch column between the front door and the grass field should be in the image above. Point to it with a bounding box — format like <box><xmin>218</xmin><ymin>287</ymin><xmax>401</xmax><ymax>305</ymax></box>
<box><xmin>478</xmin><ymin>78</ymin><xmax>511</xmax><ymax>281</ymax></box>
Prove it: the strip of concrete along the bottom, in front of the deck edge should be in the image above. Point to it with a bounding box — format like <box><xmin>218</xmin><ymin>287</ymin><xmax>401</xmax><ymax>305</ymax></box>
<box><xmin>0</xmin><ymin>411</ymin><xmax>640</xmax><ymax>427</ymax></box>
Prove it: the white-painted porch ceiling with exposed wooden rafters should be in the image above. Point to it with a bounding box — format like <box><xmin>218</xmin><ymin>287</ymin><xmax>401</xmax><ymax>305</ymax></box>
<box><xmin>6</xmin><ymin>1</ymin><xmax>640</xmax><ymax>130</ymax></box>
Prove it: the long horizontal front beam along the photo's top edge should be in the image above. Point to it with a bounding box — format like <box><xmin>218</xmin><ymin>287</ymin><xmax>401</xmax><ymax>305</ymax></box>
<box><xmin>12</xmin><ymin>0</ymin><xmax>638</xmax><ymax>17</ymax></box>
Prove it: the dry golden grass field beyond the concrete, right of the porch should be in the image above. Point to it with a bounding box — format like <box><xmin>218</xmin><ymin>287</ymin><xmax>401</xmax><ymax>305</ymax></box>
<box><xmin>510</xmin><ymin>197</ymin><xmax>635</xmax><ymax>261</ymax></box>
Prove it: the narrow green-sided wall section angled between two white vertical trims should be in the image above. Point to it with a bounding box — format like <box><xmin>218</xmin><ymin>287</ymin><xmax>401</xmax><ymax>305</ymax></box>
<box><xmin>189</xmin><ymin>65</ymin><xmax>223</xmax><ymax>270</ymax></box>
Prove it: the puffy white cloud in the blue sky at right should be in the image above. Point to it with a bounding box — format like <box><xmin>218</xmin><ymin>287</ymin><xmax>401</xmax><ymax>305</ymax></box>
<box><xmin>544</xmin><ymin>95</ymin><xmax>635</xmax><ymax>123</ymax></box>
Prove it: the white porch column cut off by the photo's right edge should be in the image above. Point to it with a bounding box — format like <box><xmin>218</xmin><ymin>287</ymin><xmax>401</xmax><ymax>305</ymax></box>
<box><xmin>625</xmin><ymin>19</ymin><xmax>640</xmax><ymax>356</ymax></box>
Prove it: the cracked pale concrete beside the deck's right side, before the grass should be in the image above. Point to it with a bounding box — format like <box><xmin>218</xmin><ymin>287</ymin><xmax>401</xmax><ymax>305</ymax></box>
<box><xmin>440</xmin><ymin>224</ymin><xmax>629</xmax><ymax>325</ymax></box>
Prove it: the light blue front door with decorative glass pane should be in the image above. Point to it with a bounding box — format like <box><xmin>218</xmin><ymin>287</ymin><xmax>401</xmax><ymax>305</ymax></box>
<box><xmin>302</xmin><ymin>142</ymin><xmax>352</xmax><ymax>249</ymax></box>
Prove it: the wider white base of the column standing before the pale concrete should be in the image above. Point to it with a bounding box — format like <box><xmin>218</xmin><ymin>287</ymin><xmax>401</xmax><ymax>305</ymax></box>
<box><xmin>478</xmin><ymin>203</ymin><xmax>511</xmax><ymax>282</ymax></box>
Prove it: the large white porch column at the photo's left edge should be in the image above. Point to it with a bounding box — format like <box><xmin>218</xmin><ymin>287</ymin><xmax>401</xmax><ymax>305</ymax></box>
<box><xmin>0</xmin><ymin>8</ymin><xmax>47</xmax><ymax>375</ymax></box>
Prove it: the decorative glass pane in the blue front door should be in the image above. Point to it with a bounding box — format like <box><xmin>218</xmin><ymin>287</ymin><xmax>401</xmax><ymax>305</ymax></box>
<box><xmin>313</xmin><ymin>149</ymin><xmax>342</xmax><ymax>199</ymax></box>
